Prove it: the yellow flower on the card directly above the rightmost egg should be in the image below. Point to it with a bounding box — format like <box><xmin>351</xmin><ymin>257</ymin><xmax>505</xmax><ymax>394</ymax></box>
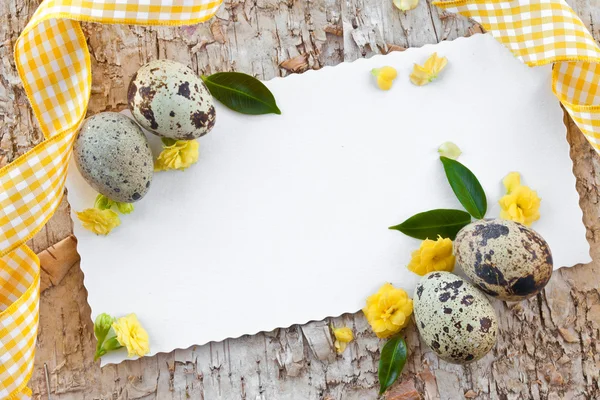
<box><xmin>498</xmin><ymin>172</ymin><xmax>542</xmax><ymax>226</ymax></box>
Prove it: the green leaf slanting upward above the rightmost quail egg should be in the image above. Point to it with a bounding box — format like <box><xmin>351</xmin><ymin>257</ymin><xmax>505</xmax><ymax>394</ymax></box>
<box><xmin>440</xmin><ymin>157</ymin><xmax>487</xmax><ymax>219</ymax></box>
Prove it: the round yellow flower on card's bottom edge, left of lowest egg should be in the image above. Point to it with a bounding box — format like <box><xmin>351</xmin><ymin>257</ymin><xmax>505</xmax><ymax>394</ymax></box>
<box><xmin>363</xmin><ymin>283</ymin><xmax>413</xmax><ymax>338</ymax></box>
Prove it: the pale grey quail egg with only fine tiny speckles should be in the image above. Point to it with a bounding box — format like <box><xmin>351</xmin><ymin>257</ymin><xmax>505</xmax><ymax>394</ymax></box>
<box><xmin>73</xmin><ymin>112</ymin><xmax>154</xmax><ymax>203</ymax></box>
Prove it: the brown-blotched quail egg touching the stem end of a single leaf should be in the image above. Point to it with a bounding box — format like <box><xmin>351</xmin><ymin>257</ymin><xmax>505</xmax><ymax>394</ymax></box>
<box><xmin>127</xmin><ymin>60</ymin><xmax>216</xmax><ymax>140</ymax></box>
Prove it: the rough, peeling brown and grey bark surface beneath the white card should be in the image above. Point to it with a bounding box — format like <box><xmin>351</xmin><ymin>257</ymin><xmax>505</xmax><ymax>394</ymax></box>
<box><xmin>0</xmin><ymin>0</ymin><xmax>600</xmax><ymax>400</ymax></box>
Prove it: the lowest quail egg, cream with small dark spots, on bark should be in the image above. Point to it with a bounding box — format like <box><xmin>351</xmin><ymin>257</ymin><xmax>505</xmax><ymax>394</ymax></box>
<box><xmin>413</xmin><ymin>272</ymin><xmax>498</xmax><ymax>364</ymax></box>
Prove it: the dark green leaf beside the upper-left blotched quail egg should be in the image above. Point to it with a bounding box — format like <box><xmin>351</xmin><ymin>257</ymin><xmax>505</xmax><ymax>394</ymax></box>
<box><xmin>202</xmin><ymin>72</ymin><xmax>281</xmax><ymax>115</ymax></box>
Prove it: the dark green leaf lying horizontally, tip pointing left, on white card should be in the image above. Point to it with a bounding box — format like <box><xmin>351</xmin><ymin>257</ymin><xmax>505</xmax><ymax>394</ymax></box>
<box><xmin>390</xmin><ymin>209</ymin><xmax>471</xmax><ymax>240</ymax></box>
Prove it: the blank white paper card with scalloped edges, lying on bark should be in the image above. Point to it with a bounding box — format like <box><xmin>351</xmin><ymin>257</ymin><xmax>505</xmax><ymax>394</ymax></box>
<box><xmin>68</xmin><ymin>35</ymin><xmax>590</xmax><ymax>363</ymax></box>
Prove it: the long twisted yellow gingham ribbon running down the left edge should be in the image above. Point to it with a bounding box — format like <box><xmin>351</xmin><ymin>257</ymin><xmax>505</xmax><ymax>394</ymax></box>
<box><xmin>0</xmin><ymin>0</ymin><xmax>222</xmax><ymax>399</ymax></box>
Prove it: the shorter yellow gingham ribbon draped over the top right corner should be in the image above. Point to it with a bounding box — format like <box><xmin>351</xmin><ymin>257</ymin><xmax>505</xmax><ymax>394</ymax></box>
<box><xmin>434</xmin><ymin>0</ymin><xmax>600</xmax><ymax>148</ymax></box>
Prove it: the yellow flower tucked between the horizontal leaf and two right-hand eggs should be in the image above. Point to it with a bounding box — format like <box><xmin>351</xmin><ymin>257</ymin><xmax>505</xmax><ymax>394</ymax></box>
<box><xmin>408</xmin><ymin>236</ymin><xmax>454</xmax><ymax>276</ymax></box>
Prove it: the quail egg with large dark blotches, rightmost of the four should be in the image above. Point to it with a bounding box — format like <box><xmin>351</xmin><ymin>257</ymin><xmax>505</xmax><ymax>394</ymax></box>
<box><xmin>454</xmin><ymin>219</ymin><xmax>553</xmax><ymax>301</ymax></box>
